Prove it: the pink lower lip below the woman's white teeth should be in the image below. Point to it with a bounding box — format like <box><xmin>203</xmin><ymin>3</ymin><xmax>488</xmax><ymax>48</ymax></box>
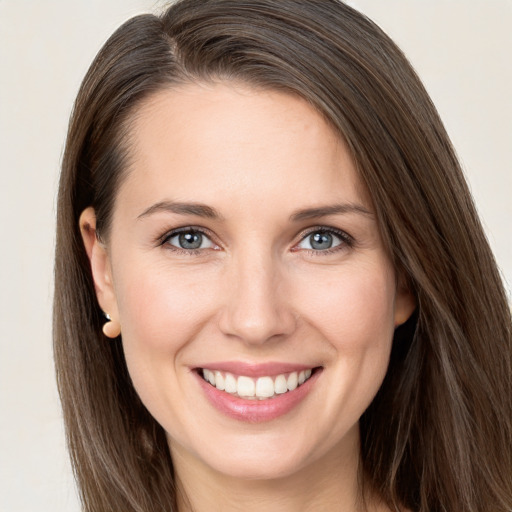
<box><xmin>194</xmin><ymin>369</ymin><xmax>321</xmax><ymax>423</ymax></box>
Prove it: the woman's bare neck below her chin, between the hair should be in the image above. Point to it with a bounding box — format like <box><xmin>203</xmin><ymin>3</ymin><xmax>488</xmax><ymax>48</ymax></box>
<box><xmin>171</xmin><ymin>433</ymin><xmax>386</xmax><ymax>512</ymax></box>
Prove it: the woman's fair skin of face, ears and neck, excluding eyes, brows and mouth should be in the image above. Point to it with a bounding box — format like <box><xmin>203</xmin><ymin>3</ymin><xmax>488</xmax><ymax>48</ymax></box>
<box><xmin>80</xmin><ymin>83</ymin><xmax>414</xmax><ymax>512</ymax></box>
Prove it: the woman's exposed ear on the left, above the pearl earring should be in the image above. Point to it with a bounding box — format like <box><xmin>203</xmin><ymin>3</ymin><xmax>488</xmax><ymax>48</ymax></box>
<box><xmin>79</xmin><ymin>207</ymin><xmax>119</xmax><ymax>320</ymax></box>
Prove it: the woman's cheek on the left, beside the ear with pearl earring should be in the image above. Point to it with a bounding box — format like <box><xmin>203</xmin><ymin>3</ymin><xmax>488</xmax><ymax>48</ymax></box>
<box><xmin>114</xmin><ymin>261</ymin><xmax>221</xmax><ymax>428</ymax></box>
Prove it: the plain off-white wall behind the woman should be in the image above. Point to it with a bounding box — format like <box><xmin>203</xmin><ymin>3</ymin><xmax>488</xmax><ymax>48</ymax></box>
<box><xmin>0</xmin><ymin>0</ymin><xmax>512</xmax><ymax>512</ymax></box>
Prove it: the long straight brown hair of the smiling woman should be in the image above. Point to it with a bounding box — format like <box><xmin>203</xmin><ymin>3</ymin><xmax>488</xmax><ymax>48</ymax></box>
<box><xmin>54</xmin><ymin>0</ymin><xmax>512</xmax><ymax>512</ymax></box>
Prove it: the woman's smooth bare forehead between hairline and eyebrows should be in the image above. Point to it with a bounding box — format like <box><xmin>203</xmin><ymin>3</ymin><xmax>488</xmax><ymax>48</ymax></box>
<box><xmin>120</xmin><ymin>83</ymin><xmax>370</xmax><ymax>215</ymax></box>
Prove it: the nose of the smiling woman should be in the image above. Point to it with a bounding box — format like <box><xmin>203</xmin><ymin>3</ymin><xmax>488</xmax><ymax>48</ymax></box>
<box><xmin>219</xmin><ymin>250</ymin><xmax>297</xmax><ymax>345</ymax></box>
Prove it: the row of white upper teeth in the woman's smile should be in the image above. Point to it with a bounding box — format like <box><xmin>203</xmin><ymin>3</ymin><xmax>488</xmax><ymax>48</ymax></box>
<box><xmin>197</xmin><ymin>368</ymin><xmax>318</xmax><ymax>400</ymax></box>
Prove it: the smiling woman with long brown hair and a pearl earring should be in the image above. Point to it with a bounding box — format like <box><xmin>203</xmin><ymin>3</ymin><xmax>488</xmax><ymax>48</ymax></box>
<box><xmin>55</xmin><ymin>0</ymin><xmax>512</xmax><ymax>512</ymax></box>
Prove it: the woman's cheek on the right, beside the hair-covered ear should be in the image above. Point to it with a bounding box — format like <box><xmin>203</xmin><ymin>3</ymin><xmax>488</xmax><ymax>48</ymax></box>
<box><xmin>296</xmin><ymin>265</ymin><xmax>395</xmax><ymax>428</ymax></box>
